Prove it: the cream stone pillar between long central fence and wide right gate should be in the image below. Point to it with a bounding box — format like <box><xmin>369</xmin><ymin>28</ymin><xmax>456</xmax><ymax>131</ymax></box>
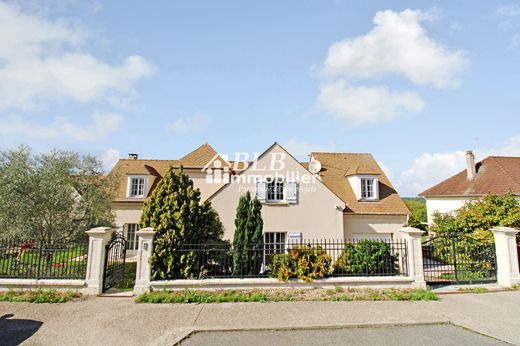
<box><xmin>399</xmin><ymin>227</ymin><xmax>426</xmax><ymax>289</ymax></box>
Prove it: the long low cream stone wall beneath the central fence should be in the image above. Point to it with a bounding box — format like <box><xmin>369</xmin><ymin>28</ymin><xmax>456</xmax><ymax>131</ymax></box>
<box><xmin>150</xmin><ymin>276</ymin><xmax>414</xmax><ymax>291</ymax></box>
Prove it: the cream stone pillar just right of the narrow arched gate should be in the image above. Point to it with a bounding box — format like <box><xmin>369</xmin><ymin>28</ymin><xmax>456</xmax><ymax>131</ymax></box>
<box><xmin>134</xmin><ymin>227</ymin><xmax>155</xmax><ymax>294</ymax></box>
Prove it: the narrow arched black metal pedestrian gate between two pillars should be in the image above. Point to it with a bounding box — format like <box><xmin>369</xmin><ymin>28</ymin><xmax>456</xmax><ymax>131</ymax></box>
<box><xmin>103</xmin><ymin>233</ymin><xmax>127</xmax><ymax>292</ymax></box>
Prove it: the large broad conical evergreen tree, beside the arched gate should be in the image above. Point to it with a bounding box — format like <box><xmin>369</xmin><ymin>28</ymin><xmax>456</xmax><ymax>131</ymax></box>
<box><xmin>140</xmin><ymin>167</ymin><xmax>224</xmax><ymax>279</ymax></box>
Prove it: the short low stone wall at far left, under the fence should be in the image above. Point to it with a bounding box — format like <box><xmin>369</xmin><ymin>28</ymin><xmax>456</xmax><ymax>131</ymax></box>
<box><xmin>0</xmin><ymin>279</ymin><xmax>88</xmax><ymax>293</ymax></box>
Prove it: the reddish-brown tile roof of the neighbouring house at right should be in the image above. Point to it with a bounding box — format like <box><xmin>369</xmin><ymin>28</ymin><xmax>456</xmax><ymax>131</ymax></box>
<box><xmin>419</xmin><ymin>156</ymin><xmax>520</xmax><ymax>197</ymax></box>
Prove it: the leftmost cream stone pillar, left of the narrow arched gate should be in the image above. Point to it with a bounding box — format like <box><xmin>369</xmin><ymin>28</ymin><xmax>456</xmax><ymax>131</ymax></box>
<box><xmin>85</xmin><ymin>227</ymin><xmax>114</xmax><ymax>294</ymax></box>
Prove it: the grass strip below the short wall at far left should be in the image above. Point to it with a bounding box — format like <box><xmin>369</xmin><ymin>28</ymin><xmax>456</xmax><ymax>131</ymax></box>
<box><xmin>0</xmin><ymin>290</ymin><xmax>81</xmax><ymax>304</ymax></box>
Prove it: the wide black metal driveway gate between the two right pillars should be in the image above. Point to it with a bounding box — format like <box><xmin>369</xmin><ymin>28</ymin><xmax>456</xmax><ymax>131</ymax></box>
<box><xmin>422</xmin><ymin>235</ymin><xmax>497</xmax><ymax>284</ymax></box>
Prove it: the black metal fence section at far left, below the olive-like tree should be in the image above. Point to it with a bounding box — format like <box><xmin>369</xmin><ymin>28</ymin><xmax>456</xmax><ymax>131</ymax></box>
<box><xmin>0</xmin><ymin>239</ymin><xmax>88</xmax><ymax>279</ymax></box>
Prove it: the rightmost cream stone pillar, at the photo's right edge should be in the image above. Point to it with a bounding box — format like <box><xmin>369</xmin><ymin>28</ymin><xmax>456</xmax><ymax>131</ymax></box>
<box><xmin>491</xmin><ymin>227</ymin><xmax>520</xmax><ymax>287</ymax></box>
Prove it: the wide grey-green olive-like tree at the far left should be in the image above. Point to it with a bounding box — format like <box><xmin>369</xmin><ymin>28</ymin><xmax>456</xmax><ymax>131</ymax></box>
<box><xmin>0</xmin><ymin>146</ymin><xmax>116</xmax><ymax>243</ymax></box>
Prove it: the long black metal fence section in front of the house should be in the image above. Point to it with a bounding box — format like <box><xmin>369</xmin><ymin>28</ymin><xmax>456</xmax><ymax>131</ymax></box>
<box><xmin>169</xmin><ymin>240</ymin><xmax>408</xmax><ymax>279</ymax></box>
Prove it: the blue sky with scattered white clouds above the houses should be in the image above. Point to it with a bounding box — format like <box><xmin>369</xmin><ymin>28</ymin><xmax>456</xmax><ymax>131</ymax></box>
<box><xmin>0</xmin><ymin>0</ymin><xmax>520</xmax><ymax>196</ymax></box>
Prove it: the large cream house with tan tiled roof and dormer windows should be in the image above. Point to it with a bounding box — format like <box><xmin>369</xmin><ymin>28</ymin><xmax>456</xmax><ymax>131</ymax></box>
<box><xmin>110</xmin><ymin>143</ymin><xmax>408</xmax><ymax>254</ymax></box>
